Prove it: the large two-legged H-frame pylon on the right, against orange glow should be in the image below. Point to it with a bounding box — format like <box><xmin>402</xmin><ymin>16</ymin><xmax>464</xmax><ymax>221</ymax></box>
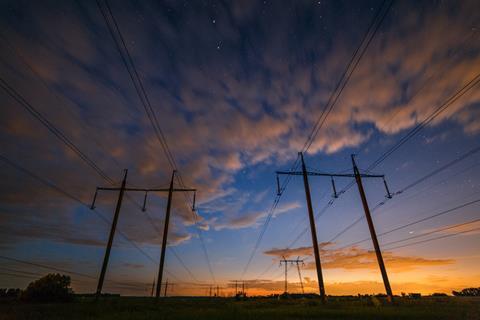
<box><xmin>276</xmin><ymin>152</ymin><xmax>393</xmax><ymax>301</ymax></box>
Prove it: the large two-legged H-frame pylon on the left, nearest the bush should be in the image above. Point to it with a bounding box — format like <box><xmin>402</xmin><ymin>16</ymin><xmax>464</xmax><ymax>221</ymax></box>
<box><xmin>90</xmin><ymin>170</ymin><xmax>197</xmax><ymax>298</ymax></box>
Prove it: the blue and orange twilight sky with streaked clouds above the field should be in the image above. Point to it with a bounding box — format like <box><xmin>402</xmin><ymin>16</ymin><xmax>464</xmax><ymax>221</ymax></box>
<box><xmin>0</xmin><ymin>0</ymin><xmax>480</xmax><ymax>295</ymax></box>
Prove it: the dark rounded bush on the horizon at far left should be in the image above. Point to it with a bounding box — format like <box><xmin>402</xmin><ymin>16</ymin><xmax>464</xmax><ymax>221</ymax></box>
<box><xmin>21</xmin><ymin>273</ymin><xmax>73</xmax><ymax>302</ymax></box>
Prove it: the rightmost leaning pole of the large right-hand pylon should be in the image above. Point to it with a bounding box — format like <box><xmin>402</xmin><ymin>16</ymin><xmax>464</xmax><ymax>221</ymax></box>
<box><xmin>352</xmin><ymin>154</ymin><xmax>393</xmax><ymax>301</ymax></box>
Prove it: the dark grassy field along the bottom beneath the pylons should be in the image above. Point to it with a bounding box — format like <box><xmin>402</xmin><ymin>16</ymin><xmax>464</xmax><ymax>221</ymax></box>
<box><xmin>0</xmin><ymin>297</ymin><xmax>480</xmax><ymax>320</ymax></box>
